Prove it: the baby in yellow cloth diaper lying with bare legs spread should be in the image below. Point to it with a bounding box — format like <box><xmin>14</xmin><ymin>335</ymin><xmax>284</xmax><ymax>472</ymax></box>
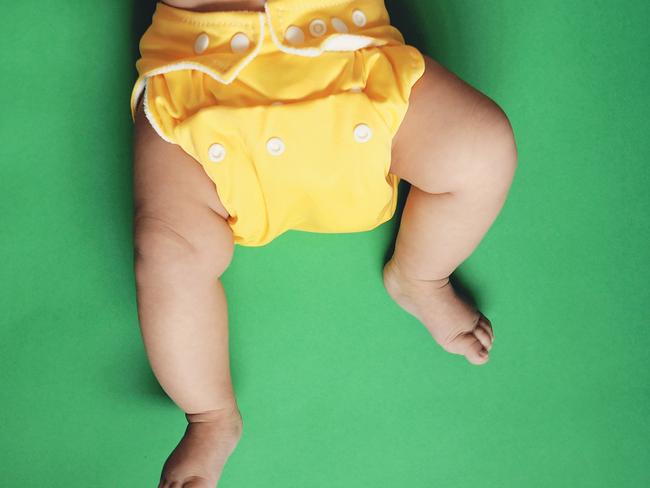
<box><xmin>131</xmin><ymin>0</ymin><xmax>517</xmax><ymax>488</ymax></box>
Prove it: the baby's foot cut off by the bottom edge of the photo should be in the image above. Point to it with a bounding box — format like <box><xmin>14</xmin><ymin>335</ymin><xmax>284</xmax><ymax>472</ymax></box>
<box><xmin>158</xmin><ymin>407</ymin><xmax>243</xmax><ymax>488</ymax></box>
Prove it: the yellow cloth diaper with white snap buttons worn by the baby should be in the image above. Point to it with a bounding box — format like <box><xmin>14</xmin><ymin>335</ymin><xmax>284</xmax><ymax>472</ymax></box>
<box><xmin>131</xmin><ymin>0</ymin><xmax>424</xmax><ymax>246</ymax></box>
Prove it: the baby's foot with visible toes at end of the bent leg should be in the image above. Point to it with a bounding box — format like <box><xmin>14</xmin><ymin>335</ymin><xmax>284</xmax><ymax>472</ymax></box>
<box><xmin>384</xmin><ymin>259</ymin><xmax>494</xmax><ymax>364</ymax></box>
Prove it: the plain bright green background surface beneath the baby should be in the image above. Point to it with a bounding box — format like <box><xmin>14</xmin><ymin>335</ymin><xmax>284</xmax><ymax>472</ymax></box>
<box><xmin>0</xmin><ymin>0</ymin><xmax>650</xmax><ymax>488</ymax></box>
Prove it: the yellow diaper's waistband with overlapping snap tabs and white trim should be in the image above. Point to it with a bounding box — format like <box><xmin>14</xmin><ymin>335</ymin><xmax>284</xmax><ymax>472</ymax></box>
<box><xmin>131</xmin><ymin>0</ymin><xmax>404</xmax><ymax>120</ymax></box>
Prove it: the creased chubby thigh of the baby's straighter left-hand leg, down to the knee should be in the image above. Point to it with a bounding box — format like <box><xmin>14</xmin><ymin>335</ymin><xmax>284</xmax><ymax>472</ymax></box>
<box><xmin>133</xmin><ymin>101</ymin><xmax>234</xmax><ymax>272</ymax></box>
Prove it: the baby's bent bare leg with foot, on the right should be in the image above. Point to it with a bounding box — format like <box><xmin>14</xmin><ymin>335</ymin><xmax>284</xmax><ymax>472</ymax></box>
<box><xmin>384</xmin><ymin>57</ymin><xmax>517</xmax><ymax>364</ymax></box>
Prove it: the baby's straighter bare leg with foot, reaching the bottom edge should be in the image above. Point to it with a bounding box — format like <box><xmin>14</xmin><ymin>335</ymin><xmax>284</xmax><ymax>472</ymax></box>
<box><xmin>134</xmin><ymin>101</ymin><xmax>242</xmax><ymax>488</ymax></box>
